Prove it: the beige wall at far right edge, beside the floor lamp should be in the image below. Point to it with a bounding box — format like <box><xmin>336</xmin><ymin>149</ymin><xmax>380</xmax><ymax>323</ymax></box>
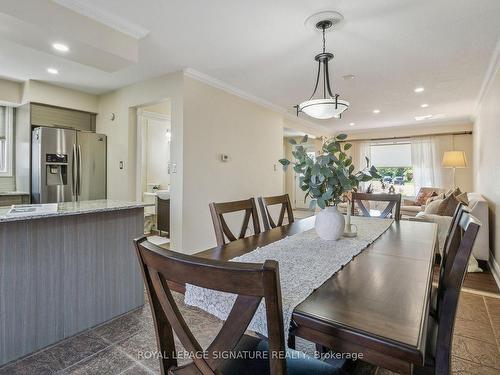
<box><xmin>474</xmin><ymin>66</ymin><xmax>500</xmax><ymax>272</ymax></box>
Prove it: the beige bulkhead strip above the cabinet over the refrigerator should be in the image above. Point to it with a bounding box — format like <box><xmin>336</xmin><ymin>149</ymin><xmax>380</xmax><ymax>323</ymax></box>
<box><xmin>22</xmin><ymin>80</ymin><xmax>98</xmax><ymax>113</ymax></box>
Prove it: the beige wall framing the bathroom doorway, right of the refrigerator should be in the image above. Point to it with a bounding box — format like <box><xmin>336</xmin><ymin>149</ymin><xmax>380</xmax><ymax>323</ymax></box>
<box><xmin>97</xmin><ymin>73</ymin><xmax>184</xmax><ymax>250</ymax></box>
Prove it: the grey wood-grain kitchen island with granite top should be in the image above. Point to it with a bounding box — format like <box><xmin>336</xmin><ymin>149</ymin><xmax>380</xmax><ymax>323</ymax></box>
<box><xmin>0</xmin><ymin>200</ymin><xmax>152</xmax><ymax>365</ymax></box>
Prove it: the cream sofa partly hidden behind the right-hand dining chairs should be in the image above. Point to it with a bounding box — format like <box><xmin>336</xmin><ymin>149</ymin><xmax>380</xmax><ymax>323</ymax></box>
<box><xmin>412</xmin><ymin>193</ymin><xmax>490</xmax><ymax>261</ymax></box>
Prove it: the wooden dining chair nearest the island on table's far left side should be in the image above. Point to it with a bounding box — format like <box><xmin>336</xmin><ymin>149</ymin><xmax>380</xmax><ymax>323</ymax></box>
<box><xmin>210</xmin><ymin>198</ymin><xmax>260</xmax><ymax>246</ymax></box>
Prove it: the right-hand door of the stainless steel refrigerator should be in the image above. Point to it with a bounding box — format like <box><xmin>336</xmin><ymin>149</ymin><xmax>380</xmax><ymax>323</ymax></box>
<box><xmin>77</xmin><ymin>132</ymin><xmax>106</xmax><ymax>201</ymax></box>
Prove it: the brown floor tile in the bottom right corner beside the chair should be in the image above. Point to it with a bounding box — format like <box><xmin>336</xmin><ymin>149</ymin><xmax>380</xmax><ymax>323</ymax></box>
<box><xmin>452</xmin><ymin>335</ymin><xmax>500</xmax><ymax>370</ymax></box>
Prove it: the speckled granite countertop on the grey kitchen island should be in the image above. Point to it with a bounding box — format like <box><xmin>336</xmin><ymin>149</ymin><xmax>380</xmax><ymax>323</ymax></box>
<box><xmin>0</xmin><ymin>199</ymin><xmax>154</xmax><ymax>223</ymax></box>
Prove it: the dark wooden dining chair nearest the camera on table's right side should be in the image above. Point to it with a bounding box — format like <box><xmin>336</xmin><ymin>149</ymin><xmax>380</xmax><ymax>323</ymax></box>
<box><xmin>414</xmin><ymin>211</ymin><xmax>481</xmax><ymax>375</ymax></box>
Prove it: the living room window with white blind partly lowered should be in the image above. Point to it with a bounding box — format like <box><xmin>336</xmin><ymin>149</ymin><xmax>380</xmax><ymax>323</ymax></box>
<box><xmin>370</xmin><ymin>142</ymin><xmax>415</xmax><ymax>196</ymax></box>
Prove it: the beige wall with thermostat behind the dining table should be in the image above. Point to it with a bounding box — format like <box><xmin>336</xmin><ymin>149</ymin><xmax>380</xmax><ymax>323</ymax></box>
<box><xmin>183</xmin><ymin>77</ymin><xmax>283</xmax><ymax>252</ymax></box>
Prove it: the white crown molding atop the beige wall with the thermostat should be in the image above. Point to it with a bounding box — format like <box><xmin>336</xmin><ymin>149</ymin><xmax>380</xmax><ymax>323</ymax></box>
<box><xmin>182</xmin><ymin>68</ymin><xmax>332</xmax><ymax>135</ymax></box>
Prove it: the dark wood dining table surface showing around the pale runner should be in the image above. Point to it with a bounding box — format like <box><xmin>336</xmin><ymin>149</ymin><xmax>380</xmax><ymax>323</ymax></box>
<box><xmin>195</xmin><ymin>217</ymin><xmax>437</xmax><ymax>374</ymax></box>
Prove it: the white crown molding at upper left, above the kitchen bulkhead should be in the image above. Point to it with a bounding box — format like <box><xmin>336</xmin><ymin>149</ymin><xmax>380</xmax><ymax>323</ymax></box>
<box><xmin>52</xmin><ymin>0</ymin><xmax>149</xmax><ymax>40</ymax></box>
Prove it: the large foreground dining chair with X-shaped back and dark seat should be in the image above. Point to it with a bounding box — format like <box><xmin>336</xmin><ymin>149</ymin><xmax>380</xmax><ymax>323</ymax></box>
<box><xmin>134</xmin><ymin>237</ymin><xmax>345</xmax><ymax>375</ymax></box>
